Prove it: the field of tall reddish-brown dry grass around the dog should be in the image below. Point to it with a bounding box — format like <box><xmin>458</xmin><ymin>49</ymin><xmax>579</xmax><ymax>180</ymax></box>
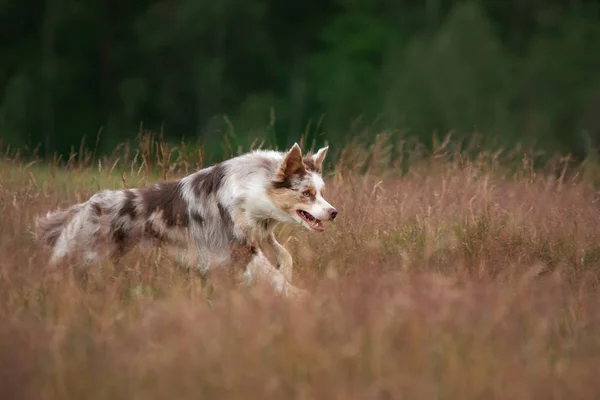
<box><xmin>0</xmin><ymin>134</ymin><xmax>600</xmax><ymax>399</ymax></box>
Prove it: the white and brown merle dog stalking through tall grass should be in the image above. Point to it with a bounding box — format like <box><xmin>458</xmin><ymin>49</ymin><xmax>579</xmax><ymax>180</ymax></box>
<box><xmin>35</xmin><ymin>143</ymin><xmax>338</xmax><ymax>296</ymax></box>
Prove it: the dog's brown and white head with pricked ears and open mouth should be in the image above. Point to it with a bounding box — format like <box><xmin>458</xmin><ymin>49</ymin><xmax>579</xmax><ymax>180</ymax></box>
<box><xmin>268</xmin><ymin>143</ymin><xmax>338</xmax><ymax>232</ymax></box>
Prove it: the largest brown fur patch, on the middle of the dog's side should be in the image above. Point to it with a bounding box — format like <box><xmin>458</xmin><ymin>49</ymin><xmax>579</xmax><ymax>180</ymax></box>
<box><xmin>140</xmin><ymin>181</ymin><xmax>189</xmax><ymax>227</ymax></box>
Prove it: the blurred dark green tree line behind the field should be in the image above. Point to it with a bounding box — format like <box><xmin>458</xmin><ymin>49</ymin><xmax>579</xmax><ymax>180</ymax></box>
<box><xmin>0</xmin><ymin>0</ymin><xmax>600</xmax><ymax>156</ymax></box>
